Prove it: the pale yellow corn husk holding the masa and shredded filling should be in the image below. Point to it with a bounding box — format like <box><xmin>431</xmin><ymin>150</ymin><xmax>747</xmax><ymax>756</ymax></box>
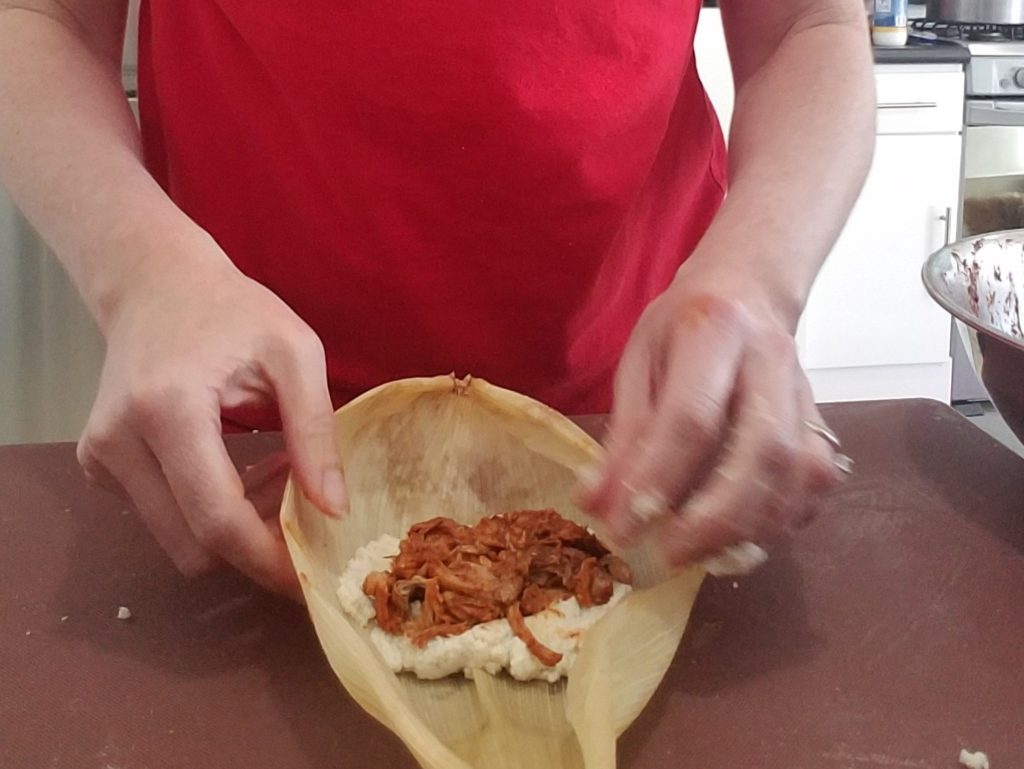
<box><xmin>282</xmin><ymin>377</ymin><xmax>703</xmax><ymax>769</ymax></box>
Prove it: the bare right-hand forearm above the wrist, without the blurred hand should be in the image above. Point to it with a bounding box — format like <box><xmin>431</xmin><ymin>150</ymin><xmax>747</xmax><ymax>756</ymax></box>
<box><xmin>693</xmin><ymin>10</ymin><xmax>874</xmax><ymax>328</ymax></box>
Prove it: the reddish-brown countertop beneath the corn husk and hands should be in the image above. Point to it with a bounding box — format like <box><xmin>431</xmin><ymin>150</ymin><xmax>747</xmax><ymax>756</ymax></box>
<box><xmin>0</xmin><ymin>400</ymin><xmax>1024</xmax><ymax>769</ymax></box>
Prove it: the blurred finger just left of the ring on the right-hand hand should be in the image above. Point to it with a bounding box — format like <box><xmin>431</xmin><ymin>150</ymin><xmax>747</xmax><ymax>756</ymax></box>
<box><xmin>660</xmin><ymin>335</ymin><xmax>802</xmax><ymax>565</ymax></box>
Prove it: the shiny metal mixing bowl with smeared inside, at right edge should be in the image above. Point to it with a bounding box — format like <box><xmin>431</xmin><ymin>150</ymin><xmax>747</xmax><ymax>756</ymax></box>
<box><xmin>922</xmin><ymin>229</ymin><xmax>1024</xmax><ymax>440</ymax></box>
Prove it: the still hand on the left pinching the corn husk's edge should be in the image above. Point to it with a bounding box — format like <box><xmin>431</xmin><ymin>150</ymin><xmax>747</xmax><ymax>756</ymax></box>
<box><xmin>78</xmin><ymin>241</ymin><xmax>347</xmax><ymax>596</ymax></box>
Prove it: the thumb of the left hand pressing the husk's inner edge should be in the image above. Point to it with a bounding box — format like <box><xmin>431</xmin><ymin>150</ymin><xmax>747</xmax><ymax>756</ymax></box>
<box><xmin>260</xmin><ymin>334</ymin><xmax>348</xmax><ymax>515</ymax></box>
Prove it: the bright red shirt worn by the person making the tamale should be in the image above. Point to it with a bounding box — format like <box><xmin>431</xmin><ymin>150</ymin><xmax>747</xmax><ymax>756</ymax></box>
<box><xmin>139</xmin><ymin>0</ymin><xmax>725</xmax><ymax>421</ymax></box>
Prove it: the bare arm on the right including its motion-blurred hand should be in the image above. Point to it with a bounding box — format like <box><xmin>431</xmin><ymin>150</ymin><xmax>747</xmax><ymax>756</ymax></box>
<box><xmin>583</xmin><ymin>0</ymin><xmax>874</xmax><ymax>564</ymax></box>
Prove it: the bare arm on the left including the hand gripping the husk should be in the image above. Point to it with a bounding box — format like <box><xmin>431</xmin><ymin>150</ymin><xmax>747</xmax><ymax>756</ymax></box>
<box><xmin>0</xmin><ymin>0</ymin><xmax>345</xmax><ymax>592</ymax></box>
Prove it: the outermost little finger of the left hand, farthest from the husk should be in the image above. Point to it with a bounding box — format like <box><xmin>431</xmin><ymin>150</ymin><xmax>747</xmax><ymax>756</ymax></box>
<box><xmin>78</xmin><ymin>429</ymin><xmax>217</xmax><ymax>576</ymax></box>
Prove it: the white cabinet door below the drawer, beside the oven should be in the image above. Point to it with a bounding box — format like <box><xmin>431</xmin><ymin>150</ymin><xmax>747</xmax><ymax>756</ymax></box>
<box><xmin>798</xmin><ymin>134</ymin><xmax>962</xmax><ymax>400</ymax></box>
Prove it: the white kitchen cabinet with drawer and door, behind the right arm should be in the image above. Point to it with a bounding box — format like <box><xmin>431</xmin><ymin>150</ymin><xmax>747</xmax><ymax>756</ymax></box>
<box><xmin>694</xmin><ymin>9</ymin><xmax>964</xmax><ymax>401</ymax></box>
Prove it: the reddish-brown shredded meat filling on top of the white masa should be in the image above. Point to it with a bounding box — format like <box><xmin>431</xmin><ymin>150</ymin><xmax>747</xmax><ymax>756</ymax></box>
<box><xmin>362</xmin><ymin>510</ymin><xmax>633</xmax><ymax>667</ymax></box>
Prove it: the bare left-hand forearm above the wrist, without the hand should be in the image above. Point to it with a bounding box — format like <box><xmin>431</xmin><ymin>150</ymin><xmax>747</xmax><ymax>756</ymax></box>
<box><xmin>0</xmin><ymin>3</ymin><xmax>226</xmax><ymax>327</ymax></box>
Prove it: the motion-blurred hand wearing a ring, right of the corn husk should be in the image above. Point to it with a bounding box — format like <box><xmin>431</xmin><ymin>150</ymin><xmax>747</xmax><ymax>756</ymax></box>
<box><xmin>582</xmin><ymin>259</ymin><xmax>850</xmax><ymax>566</ymax></box>
